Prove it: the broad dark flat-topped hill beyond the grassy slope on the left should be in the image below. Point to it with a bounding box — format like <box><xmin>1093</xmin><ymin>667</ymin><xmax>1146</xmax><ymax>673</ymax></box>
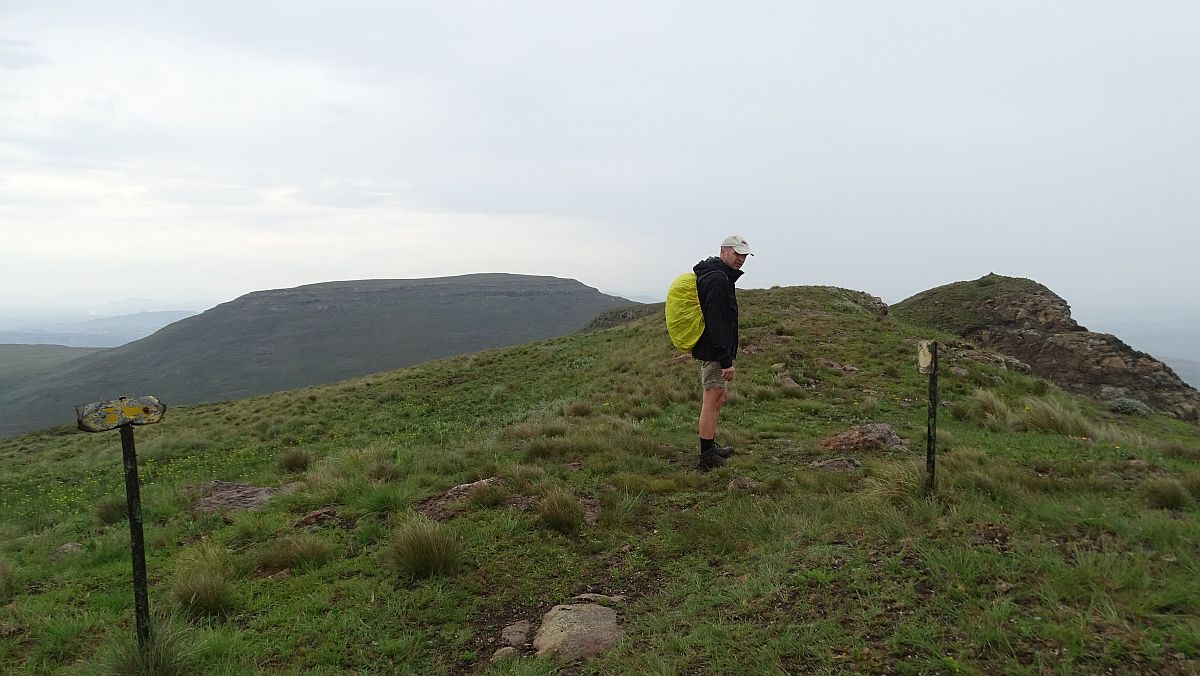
<box><xmin>0</xmin><ymin>274</ymin><xmax>629</xmax><ymax>436</ymax></box>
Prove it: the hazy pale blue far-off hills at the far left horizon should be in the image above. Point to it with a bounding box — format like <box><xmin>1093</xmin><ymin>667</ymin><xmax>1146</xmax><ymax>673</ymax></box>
<box><xmin>0</xmin><ymin>310</ymin><xmax>196</xmax><ymax>347</ymax></box>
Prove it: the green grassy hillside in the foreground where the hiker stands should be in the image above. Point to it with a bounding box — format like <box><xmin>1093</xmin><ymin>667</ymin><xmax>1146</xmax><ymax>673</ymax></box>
<box><xmin>0</xmin><ymin>287</ymin><xmax>1200</xmax><ymax>675</ymax></box>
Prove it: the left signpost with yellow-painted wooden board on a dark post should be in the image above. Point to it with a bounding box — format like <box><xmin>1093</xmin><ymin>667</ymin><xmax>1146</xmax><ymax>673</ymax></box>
<box><xmin>76</xmin><ymin>396</ymin><xmax>167</xmax><ymax>648</ymax></box>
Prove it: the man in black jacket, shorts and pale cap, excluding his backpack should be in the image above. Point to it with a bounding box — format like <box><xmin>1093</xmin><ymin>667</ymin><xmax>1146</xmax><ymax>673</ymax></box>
<box><xmin>691</xmin><ymin>234</ymin><xmax>754</xmax><ymax>472</ymax></box>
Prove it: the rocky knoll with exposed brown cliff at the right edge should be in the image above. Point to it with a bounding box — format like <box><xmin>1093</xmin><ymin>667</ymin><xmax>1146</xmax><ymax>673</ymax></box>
<box><xmin>892</xmin><ymin>274</ymin><xmax>1200</xmax><ymax>421</ymax></box>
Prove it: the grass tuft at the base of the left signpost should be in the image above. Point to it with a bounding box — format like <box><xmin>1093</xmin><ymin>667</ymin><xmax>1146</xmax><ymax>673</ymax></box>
<box><xmin>101</xmin><ymin>612</ymin><xmax>197</xmax><ymax>676</ymax></box>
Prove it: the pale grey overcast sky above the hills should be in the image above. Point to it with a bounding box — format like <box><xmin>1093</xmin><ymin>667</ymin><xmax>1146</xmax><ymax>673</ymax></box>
<box><xmin>0</xmin><ymin>0</ymin><xmax>1200</xmax><ymax>323</ymax></box>
